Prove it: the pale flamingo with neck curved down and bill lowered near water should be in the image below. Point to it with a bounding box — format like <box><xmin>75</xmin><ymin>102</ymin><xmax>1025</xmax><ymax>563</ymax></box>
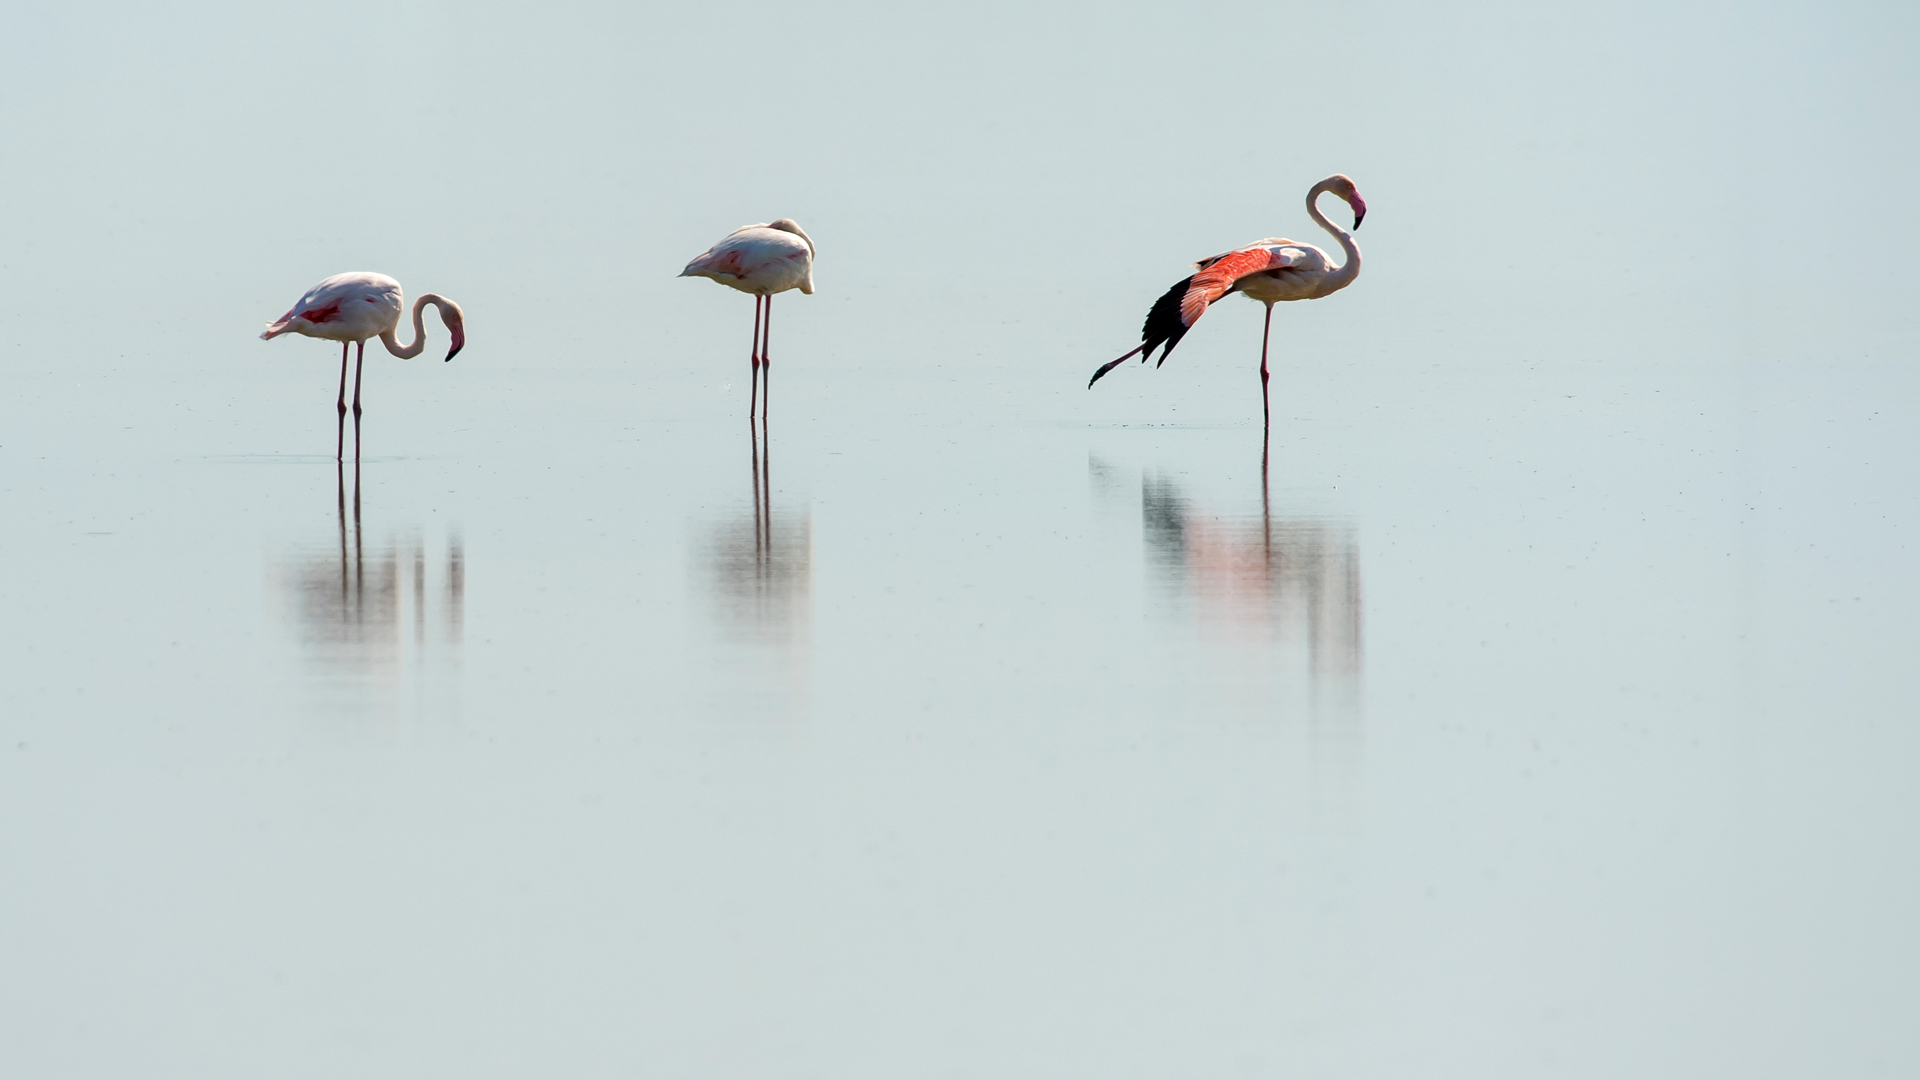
<box><xmin>261</xmin><ymin>271</ymin><xmax>467</xmax><ymax>438</ymax></box>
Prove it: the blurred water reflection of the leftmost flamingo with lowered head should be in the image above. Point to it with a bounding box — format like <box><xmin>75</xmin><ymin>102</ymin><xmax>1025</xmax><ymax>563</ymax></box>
<box><xmin>276</xmin><ymin>461</ymin><xmax>467</xmax><ymax>686</ymax></box>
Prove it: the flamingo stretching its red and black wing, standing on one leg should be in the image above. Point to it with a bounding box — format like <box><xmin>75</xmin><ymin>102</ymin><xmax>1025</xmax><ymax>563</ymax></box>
<box><xmin>1087</xmin><ymin>173</ymin><xmax>1367</xmax><ymax>423</ymax></box>
